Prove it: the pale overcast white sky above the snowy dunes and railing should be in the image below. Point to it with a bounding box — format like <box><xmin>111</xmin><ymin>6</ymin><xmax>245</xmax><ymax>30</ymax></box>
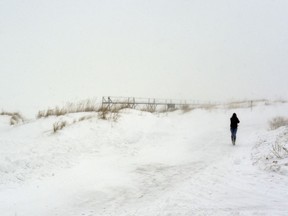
<box><xmin>0</xmin><ymin>0</ymin><xmax>288</xmax><ymax>114</ymax></box>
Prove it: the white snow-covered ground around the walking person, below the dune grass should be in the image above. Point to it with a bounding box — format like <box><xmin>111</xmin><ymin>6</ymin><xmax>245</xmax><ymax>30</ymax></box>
<box><xmin>0</xmin><ymin>104</ymin><xmax>288</xmax><ymax>216</ymax></box>
